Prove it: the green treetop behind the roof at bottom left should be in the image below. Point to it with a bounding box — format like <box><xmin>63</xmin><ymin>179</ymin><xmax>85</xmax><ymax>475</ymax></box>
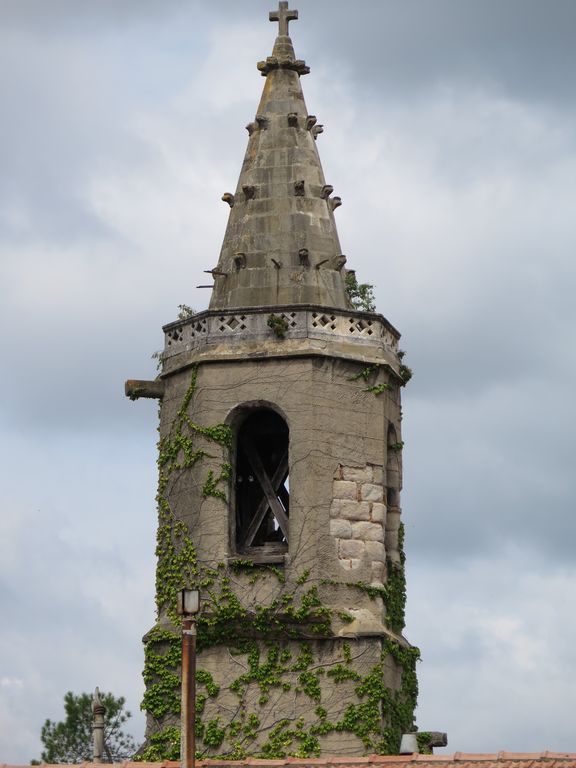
<box><xmin>35</xmin><ymin>691</ymin><xmax>136</xmax><ymax>763</ymax></box>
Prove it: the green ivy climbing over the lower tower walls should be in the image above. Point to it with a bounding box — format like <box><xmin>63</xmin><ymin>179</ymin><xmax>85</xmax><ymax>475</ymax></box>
<box><xmin>140</xmin><ymin>368</ymin><xmax>418</xmax><ymax>760</ymax></box>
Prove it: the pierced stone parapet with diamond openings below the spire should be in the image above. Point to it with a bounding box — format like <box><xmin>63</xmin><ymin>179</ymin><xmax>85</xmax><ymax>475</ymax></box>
<box><xmin>163</xmin><ymin>306</ymin><xmax>400</xmax><ymax>360</ymax></box>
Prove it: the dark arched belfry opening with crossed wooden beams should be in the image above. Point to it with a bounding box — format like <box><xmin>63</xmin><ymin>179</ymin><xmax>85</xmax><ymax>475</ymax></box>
<box><xmin>235</xmin><ymin>408</ymin><xmax>290</xmax><ymax>561</ymax></box>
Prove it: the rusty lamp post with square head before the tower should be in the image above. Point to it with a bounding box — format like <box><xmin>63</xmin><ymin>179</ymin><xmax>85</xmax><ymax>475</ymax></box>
<box><xmin>178</xmin><ymin>589</ymin><xmax>200</xmax><ymax>768</ymax></box>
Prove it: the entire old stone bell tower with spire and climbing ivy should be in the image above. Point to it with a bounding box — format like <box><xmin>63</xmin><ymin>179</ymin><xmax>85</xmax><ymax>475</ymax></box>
<box><xmin>126</xmin><ymin>2</ymin><xmax>418</xmax><ymax>759</ymax></box>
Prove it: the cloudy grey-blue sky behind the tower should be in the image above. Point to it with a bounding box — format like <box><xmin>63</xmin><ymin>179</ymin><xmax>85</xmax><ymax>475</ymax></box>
<box><xmin>0</xmin><ymin>0</ymin><xmax>576</xmax><ymax>763</ymax></box>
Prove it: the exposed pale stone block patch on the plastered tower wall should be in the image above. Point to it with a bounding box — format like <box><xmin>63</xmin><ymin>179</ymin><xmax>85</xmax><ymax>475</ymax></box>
<box><xmin>330</xmin><ymin>464</ymin><xmax>386</xmax><ymax>584</ymax></box>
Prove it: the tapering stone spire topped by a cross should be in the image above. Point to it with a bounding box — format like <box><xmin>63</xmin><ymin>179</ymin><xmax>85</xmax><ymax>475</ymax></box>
<box><xmin>210</xmin><ymin>2</ymin><xmax>349</xmax><ymax>309</ymax></box>
